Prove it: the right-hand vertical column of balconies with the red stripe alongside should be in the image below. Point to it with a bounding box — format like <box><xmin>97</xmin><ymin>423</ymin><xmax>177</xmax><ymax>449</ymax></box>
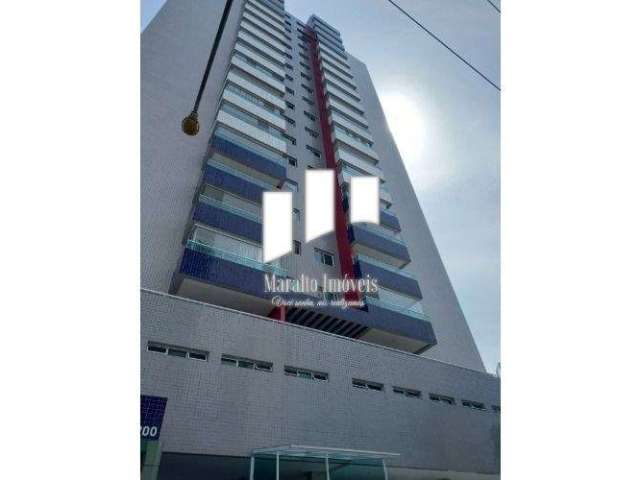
<box><xmin>308</xmin><ymin>16</ymin><xmax>426</xmax><ymax>319</ymax></box>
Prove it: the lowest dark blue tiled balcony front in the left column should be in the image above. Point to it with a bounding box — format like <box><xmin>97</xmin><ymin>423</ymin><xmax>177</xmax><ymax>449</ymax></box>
<box><xmin>178</xmin><ymin>248</ymin><xmax>266</xmax><ymax>298</ymax></box>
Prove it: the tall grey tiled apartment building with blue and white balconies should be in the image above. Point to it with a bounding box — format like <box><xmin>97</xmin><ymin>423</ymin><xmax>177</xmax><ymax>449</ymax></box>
<box><xmin>141</xmin><ymin>0</ymin><xmax>500</xmax><ymax>480</ymax></box>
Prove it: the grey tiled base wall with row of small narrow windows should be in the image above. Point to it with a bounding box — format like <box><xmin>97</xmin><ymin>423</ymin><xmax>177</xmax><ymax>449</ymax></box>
<box><xmin>141</xmin><ymin>290</ymin><xmax>500</xmax><ymax>480</ymax></box>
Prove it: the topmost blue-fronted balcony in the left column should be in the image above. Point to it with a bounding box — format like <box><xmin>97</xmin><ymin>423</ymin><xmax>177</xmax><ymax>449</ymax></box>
<box><xmin>211</xmin><ymin>129</ymin><xmax>287</xmax><ymax>186</ymax></box>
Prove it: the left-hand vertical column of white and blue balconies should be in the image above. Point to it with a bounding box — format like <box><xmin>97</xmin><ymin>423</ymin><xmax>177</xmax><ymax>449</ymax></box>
<box><xmin>173</xmin><ymin>0</ymin><xmax>295</xmax><ymax>307</ymax></box>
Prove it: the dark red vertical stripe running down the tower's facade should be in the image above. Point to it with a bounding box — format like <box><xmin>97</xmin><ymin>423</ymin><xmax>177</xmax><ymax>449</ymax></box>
<box><xmin>307</xmin><ymin>27</ymin><xmax>360</xmax><ymax>301</ymax></box>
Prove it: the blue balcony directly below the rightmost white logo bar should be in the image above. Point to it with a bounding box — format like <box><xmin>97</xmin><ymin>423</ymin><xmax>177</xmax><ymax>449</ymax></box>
<box><xmin>349</xmin><ymin>224</ymin><xmax>411</xmax><ymax>268</ymax></box>
